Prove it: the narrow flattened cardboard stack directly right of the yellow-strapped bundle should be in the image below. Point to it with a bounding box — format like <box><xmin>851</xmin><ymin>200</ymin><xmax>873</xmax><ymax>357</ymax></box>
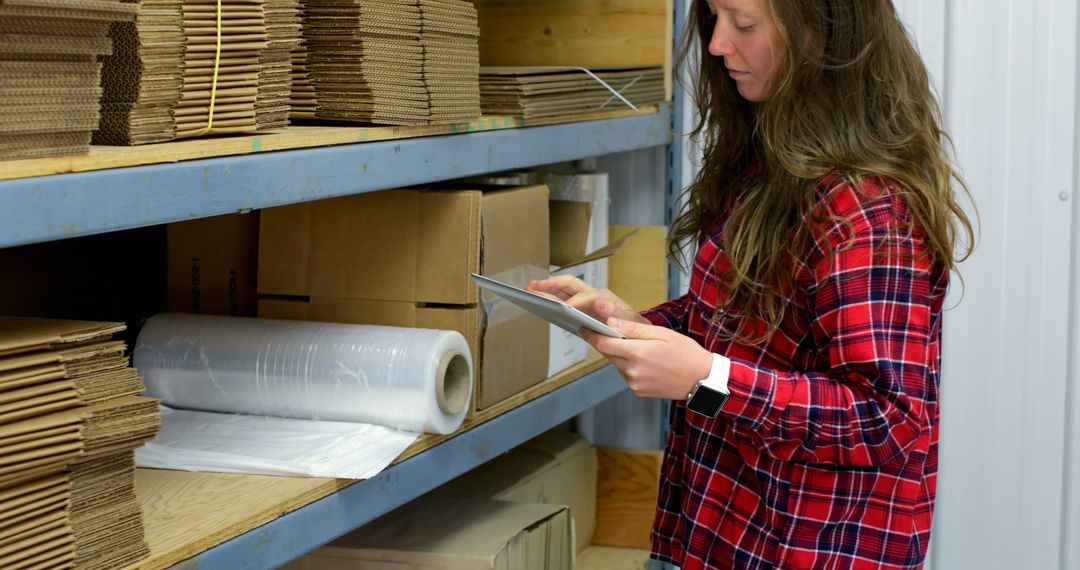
<box><xmin>255</xmin><ymin>0</ymin><xmax>300</xmax><ymax>131</ymax></box>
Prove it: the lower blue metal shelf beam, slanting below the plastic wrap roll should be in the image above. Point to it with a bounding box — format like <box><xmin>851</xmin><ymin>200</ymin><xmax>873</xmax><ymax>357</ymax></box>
<box><xmin>174</xmin><ymin>366</ymin><xmax>626</xmax><ymax>570</ymax></box>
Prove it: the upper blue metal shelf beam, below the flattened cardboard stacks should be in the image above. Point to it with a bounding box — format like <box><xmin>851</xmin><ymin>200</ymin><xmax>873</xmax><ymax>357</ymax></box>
<box><xmin>0</xmin><ymin>105</ymin><xmax>672</xmax><ymax>247</ymax></box>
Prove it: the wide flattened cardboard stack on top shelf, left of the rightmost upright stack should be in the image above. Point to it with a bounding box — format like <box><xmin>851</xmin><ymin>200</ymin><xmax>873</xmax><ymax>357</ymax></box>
<box><xmin>303</xmin><ymin>0</ymin><xmax>429</xmax><ymax>125</ymax></box>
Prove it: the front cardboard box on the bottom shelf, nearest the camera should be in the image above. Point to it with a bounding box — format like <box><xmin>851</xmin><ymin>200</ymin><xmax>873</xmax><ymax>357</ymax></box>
<box><xmin>284</xmin><ymin>496</ymin><xmax>575</xmax><ymax>570</ymax></box>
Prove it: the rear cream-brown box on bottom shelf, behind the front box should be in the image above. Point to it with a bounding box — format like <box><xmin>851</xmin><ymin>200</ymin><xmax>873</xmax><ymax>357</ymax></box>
<box><xmin>432</xmin><ymin>430</ymin><xmax>598</xmax><ymax>552</ymax></box>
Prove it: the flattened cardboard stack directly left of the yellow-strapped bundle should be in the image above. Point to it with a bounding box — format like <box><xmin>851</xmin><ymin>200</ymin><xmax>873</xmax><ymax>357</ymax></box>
<box><xmin>94</xmin><ymin>0</ymin><xmax>185</xmax><ymax>145</ymax></box>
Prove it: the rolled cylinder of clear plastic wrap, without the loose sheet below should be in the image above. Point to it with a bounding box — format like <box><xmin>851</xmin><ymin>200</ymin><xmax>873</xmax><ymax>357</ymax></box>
<box><xmin>134</xmin><ymin>313</ymin><xmax>473</xmax><ymax>434</ymax></box>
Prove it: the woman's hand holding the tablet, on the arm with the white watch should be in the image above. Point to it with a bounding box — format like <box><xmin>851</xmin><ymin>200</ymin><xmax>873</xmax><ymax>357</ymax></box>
<box><xmin>581</xmin><ymin>318</ymin><xmax>713</xmax><ymax>401</ymax></box>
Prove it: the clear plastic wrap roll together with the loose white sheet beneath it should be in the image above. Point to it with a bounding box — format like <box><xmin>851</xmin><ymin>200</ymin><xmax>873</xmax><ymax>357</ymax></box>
<box><xmin>134</xmin><ymin>313</ymin><xmax>473</xmax><ymax>478</ymax></box>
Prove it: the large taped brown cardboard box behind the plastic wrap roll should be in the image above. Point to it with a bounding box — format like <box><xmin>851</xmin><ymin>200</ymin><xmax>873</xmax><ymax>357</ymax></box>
<box><xmin>259</xmin><ymin>186</ymin><xmax>549</xmax><ymax>410</ymax></box>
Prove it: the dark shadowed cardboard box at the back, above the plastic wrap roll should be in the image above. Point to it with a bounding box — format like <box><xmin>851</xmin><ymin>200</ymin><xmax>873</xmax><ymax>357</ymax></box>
<box><xmin>166</xmin><ymin>213</ymin><xmax>259</xmax><ymax>316</ymax></box>
